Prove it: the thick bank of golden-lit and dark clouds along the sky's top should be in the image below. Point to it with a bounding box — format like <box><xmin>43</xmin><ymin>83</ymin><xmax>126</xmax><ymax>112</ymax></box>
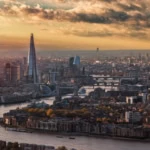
<box><xmin>1</xmin><ymin>0</ymin><xmax>150</xmax><ymax>24</ymax></box>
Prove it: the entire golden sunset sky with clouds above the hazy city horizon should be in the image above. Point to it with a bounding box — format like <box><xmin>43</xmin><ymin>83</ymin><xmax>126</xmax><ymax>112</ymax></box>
<box><xmin>0</xmin><ymin>0</ymin><xmax>150</xmax><ymax>52</ymax></box>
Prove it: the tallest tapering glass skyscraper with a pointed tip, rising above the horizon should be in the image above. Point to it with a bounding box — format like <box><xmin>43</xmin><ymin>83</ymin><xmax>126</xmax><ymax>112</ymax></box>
<box><xmin>27</xmin><ymin>34</ymin><xmax>38</xmax><ymax>83</ymax></box>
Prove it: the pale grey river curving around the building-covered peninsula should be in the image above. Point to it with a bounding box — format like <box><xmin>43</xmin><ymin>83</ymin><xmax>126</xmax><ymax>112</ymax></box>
<box><xmin>0</xmin><ymin>98</ymin><xmax>150</xmax><ymax>150</ymax></box>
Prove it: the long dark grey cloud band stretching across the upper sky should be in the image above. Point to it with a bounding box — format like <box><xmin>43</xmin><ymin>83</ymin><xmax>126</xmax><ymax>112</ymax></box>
<box><xmin>1</xmin><ymin>4</ymin><xmax>130</xmax><ymax>24</ymax></box>
